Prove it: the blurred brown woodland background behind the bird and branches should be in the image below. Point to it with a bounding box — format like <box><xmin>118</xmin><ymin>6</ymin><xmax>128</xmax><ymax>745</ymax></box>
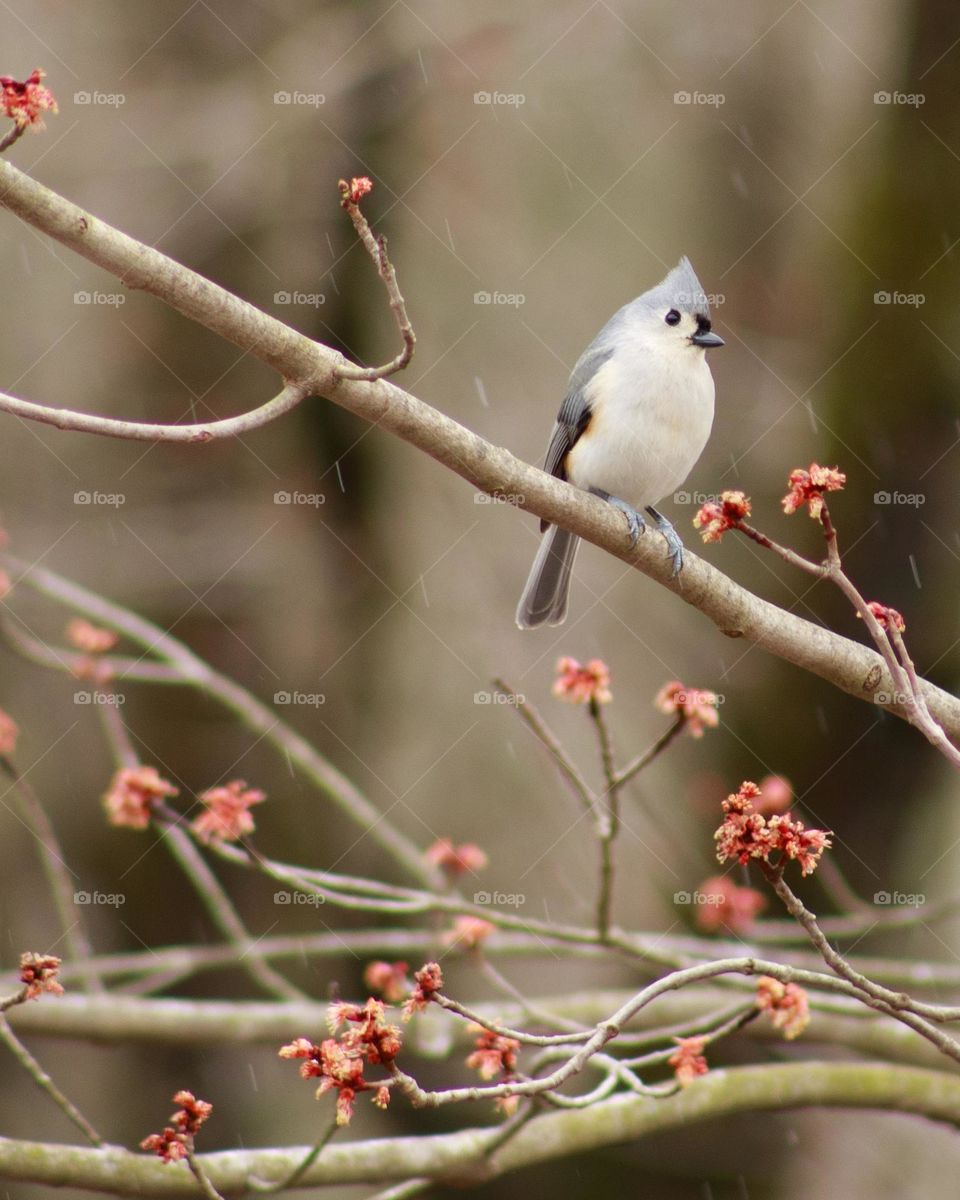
<box><xmin>0</xmin><ymin>0</ymin><xmax>960</xmax><ymax>1200</ymax></box>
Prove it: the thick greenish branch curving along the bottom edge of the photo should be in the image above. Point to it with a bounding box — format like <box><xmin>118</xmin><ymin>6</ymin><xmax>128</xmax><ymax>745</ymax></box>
<box><xmin>0</xmin><ymin>1062</ymin><xmax>960</xmax><ymax>1196</ymax></box>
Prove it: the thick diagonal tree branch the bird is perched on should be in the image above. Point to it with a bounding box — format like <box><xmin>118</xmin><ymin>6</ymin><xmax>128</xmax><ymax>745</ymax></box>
<box><xmin>0</xmin><ymin>161</ymin><xmax>960</xmax><ymax>739</ymax></box>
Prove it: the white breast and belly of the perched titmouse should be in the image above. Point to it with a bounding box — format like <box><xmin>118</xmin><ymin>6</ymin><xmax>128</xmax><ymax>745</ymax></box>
<box><xmin>568</xmin><ymin>344</ymin><xmax>714</xmax><ymax>509</ymax></box>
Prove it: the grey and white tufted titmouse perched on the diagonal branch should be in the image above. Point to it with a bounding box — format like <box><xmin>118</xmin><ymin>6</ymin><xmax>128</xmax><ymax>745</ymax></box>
<box><xmin>517</xmin><ymin>258</ymin><xmax>724</xmax><ymax>629</ymax></box>
